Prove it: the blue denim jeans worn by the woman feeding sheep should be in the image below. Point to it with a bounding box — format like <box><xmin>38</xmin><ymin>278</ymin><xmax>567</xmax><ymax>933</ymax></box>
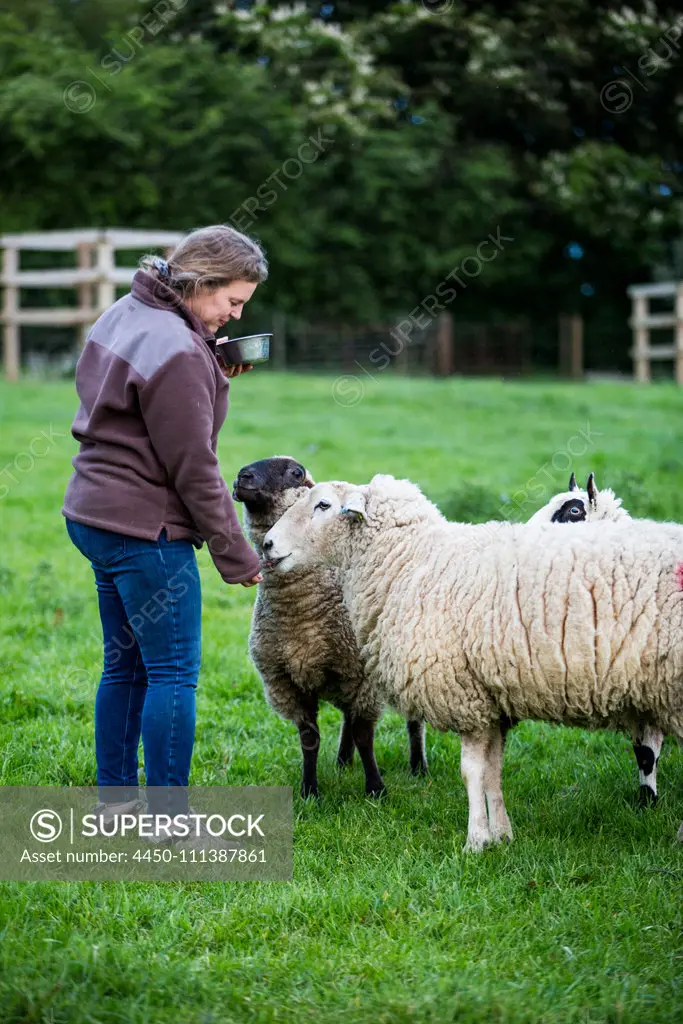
<box><xmin>67</xmin><ymin>519</ymin><xmax>202</xmax><ymax>813</ymax></box>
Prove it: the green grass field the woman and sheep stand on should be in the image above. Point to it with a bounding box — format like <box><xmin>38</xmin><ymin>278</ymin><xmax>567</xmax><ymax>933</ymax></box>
<box><xmin>0</xmin><ymin>372</ymin><xmax>683</xmax><ymax>1024</ymax></box>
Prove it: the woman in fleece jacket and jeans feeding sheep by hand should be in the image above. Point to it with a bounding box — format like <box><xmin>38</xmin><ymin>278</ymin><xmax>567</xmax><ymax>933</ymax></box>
<box><xmin>62</xmin><ymin>224</ymin><xmax>267</xmax><ymax>816</ymax></box>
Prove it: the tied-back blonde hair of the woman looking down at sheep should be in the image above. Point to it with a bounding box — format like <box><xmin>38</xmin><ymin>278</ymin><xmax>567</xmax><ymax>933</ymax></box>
<box><xmin>140</xmin><ymin>224</ymin><xmax>268</xmax><ymax>299</ymax></box>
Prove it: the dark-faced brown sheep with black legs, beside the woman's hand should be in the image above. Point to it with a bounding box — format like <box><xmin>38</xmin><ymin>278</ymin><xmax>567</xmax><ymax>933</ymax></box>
<box><xmin>232</xmin><ymin>456</ymin><xmax>427</xmax><ymax>797</ymax></box>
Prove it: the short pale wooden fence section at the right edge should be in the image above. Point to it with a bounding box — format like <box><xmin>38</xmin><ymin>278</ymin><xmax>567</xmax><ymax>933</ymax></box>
<box><xmin>628</xmin><ymin>281</ymin><xmax>683</xmax><ymax>387</ymax></box>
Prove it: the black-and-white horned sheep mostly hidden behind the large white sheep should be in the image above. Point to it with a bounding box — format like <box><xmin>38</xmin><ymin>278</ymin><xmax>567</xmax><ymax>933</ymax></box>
<box><xmin>527</xmin><ymin>473</ymin><xmax>664</xmax><ymax>806</ymax></box>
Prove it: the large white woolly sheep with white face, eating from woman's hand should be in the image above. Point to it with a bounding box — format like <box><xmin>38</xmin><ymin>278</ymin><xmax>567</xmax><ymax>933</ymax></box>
<box><xmin>263</xmin><ymin>475</ymin><xmax>683</xmax><ymax>850</ymax></box>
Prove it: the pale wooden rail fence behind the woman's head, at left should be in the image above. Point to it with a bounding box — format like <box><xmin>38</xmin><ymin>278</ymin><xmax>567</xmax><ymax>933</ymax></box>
<box><xmin>0</xmin><ymin>228</ymin><xmax>182</xmax><ymax>380</ymax></box>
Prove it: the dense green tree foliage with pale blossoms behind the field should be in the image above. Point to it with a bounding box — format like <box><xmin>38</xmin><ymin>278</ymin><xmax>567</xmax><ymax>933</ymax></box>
<box><xmin>0</xmin><ymin>0</ymin><xmax>683</xmax><ymax>346</ymax></box>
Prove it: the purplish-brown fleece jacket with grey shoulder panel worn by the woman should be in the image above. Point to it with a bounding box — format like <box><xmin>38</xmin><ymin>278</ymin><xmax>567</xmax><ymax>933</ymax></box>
<box><xmin>62</xmin><ymin>270</ymin><xmax>259</xmax><ymax>583</ymax></box>
